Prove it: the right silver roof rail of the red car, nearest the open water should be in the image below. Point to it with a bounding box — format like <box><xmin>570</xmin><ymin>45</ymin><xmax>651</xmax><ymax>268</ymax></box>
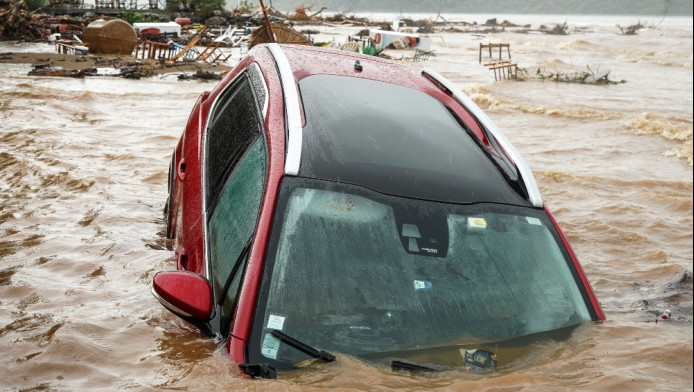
<box><xmin>422</xmin><ymin>68</ymin><xmax>543</xmax><ymax>207</ymax></box>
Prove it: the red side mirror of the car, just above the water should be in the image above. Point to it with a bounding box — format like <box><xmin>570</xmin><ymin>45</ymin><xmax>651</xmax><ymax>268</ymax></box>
<box><xmin>152</xmin><ymin>271</ymin><xmax>212</xmax><ymax>326</ymax></box>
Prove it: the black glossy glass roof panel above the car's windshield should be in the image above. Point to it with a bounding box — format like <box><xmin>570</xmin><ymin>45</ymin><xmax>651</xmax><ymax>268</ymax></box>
<box><xmin>298</xmin><ymin>75</ymin><xmax>529</xmax><ymax>205</ymax></box>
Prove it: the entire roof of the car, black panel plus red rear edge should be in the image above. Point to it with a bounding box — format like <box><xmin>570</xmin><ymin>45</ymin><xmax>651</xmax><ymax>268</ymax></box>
<box><xmin>270</xmin><ymin>45</ymin><xmax>528</xmax><ymax>205</ymax></box>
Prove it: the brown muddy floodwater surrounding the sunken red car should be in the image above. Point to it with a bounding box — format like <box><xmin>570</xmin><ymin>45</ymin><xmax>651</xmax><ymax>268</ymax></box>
<box><xmin>0</xmin><ymin>16</ymin><xmax>693</xmax><ymax>391</ymax></box>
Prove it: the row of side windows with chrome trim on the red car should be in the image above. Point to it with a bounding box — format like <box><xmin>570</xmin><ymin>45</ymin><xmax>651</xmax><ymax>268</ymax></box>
<box><xmin>204</xmin><ymin>67</ymin><xmax>268</xmax><ymax>339</ymax></box>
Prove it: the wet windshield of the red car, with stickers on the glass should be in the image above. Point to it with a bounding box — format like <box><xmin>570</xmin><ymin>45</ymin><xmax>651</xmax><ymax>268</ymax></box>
<box><xmin>249</xmin><ymin>177</ymin><xmax>591</xmax><ymax>367</ymax></box>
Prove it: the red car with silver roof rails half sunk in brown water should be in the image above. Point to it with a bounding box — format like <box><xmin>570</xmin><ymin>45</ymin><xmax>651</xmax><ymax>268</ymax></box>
<box><xmin>153</xmin><ymin>44</ymin><xmax>605</xmax><ymax>377</ymax></box>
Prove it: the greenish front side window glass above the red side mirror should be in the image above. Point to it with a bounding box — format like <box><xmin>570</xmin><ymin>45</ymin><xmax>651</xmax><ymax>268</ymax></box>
<box><xmin>208</xmin><ymin>137</ymin><xmax>267</xmax><ymax>311</ymax></box>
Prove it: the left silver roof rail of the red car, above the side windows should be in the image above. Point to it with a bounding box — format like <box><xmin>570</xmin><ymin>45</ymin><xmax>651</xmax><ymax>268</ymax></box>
<box><xmin>268</xmin><ymin>43</ymin><xmax>303</xmax><ymax>175</ymax></box>
